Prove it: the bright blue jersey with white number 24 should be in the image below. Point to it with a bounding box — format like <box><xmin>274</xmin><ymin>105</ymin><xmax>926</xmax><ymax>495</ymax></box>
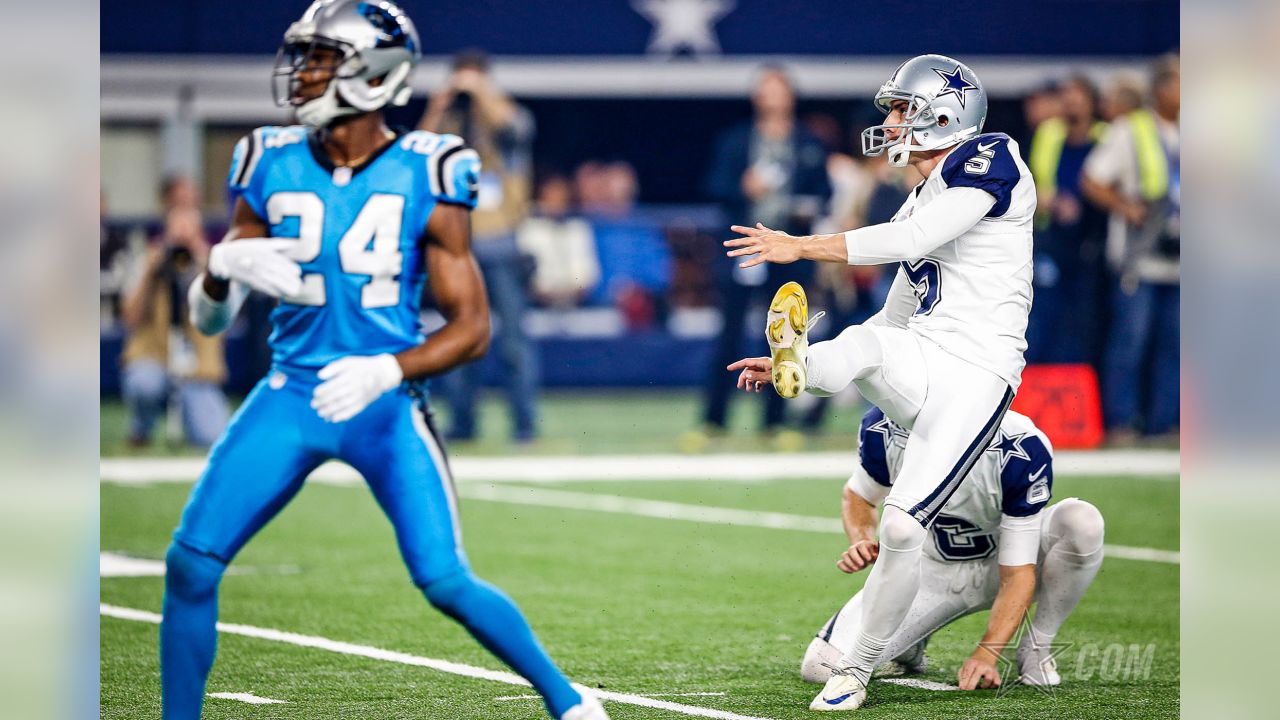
<box><xmin>228</xmin><ymin>126</ymin><xmax>480</xmax><ymax>375</ymax></box>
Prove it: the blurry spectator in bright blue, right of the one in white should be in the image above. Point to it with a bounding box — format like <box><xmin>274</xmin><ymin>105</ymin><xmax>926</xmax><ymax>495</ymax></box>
<box><xmin>576</xmin><ymin>161</ymin><xmax>672</xmax><ymax>331</ymax></box>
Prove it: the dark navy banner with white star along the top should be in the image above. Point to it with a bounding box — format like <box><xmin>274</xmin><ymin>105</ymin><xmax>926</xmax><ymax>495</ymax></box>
<box><xmin>101</xmin><ymin>0</ymin><xmax>1179</xmax><ymax>58</ymax></box>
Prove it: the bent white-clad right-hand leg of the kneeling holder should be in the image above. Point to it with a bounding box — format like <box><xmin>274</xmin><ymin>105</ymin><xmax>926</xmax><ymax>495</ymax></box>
<box><xmin>1018</xmin><ymin>497</ymin><xmax>1103</xmax><ymax>685</ymax></box>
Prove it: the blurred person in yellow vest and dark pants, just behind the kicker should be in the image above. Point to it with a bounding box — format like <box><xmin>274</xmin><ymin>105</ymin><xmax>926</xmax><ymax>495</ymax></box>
<box><xmin>1028</xmin><ymin>76</ymin><xmax>1107</xmax><ymax>365</ymax></box>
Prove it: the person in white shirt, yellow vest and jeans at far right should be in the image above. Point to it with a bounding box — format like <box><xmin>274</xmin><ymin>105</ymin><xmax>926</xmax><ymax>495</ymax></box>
<box><xmin>1082</xmin><ymin>55</ymin><xmax>1181</xmax><ymax>445</ymax></box>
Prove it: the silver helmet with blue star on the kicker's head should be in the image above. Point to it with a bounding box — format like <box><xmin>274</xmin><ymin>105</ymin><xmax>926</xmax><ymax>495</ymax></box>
<box><xmin>863</xmin><ymin>55</ymin><xmax>987</xmax><ymax>168</ymax></box>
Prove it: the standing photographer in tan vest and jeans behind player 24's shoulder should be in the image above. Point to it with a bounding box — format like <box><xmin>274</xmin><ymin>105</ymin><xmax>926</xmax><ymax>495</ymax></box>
<box><xmin>419</xmin><ymin>50</ymin><xmax>539</xmax><ymax>442</ymax></box>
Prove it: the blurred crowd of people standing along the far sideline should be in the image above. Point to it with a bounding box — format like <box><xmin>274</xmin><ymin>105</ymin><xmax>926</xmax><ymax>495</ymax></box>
<box><xmin>101</xmin><ymin>53</ymin><xmax>1180</xmax><ymax>445</ymax></box>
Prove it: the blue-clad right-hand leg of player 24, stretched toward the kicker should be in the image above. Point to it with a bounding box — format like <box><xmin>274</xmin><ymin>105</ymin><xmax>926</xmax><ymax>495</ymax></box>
<box><xmin>342</xmin><ymin>391</ymin><xmax>605</xmax><ymax>720</ymax></box>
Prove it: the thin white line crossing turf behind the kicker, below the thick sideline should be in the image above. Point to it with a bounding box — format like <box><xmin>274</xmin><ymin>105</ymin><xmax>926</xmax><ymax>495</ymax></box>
<box><xmin>458</xmin><ymin>483</ymin><xmax>1181</xmax><ymax>565</ymax></box>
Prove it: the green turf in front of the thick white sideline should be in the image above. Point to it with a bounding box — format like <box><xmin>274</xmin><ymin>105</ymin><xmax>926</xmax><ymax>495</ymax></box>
<box><xmin>101</xmin><ymin>471</ymin><xmax>1179</xmax><ymax>720</ymax></box>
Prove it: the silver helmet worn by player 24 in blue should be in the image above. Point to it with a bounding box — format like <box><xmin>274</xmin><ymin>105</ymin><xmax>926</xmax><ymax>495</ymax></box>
<box><xmin>271</xmin><ymin>0</ymin><xmax>422</xmax><ymax>127</ymax></box>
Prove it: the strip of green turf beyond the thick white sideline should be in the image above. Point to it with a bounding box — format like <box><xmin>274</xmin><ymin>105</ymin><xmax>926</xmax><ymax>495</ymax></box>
<box><xmin>101</xmin><ymin>389</ymin><xmax>863</xmax><ymax>456</ymax></box>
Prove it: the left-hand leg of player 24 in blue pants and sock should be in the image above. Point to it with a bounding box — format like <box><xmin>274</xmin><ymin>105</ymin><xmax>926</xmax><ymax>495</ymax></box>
<box><xmin>160</xmin><ymin>374</ymin><xmax>332</xmax><ymax>720</ymax></box>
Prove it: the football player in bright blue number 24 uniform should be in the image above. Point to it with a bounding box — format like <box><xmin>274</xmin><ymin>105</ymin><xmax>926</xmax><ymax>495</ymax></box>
<box><xmin>160</xmin><ymin>0</ymin><xmax>607</xmax><ymax>720</ymax></box>
